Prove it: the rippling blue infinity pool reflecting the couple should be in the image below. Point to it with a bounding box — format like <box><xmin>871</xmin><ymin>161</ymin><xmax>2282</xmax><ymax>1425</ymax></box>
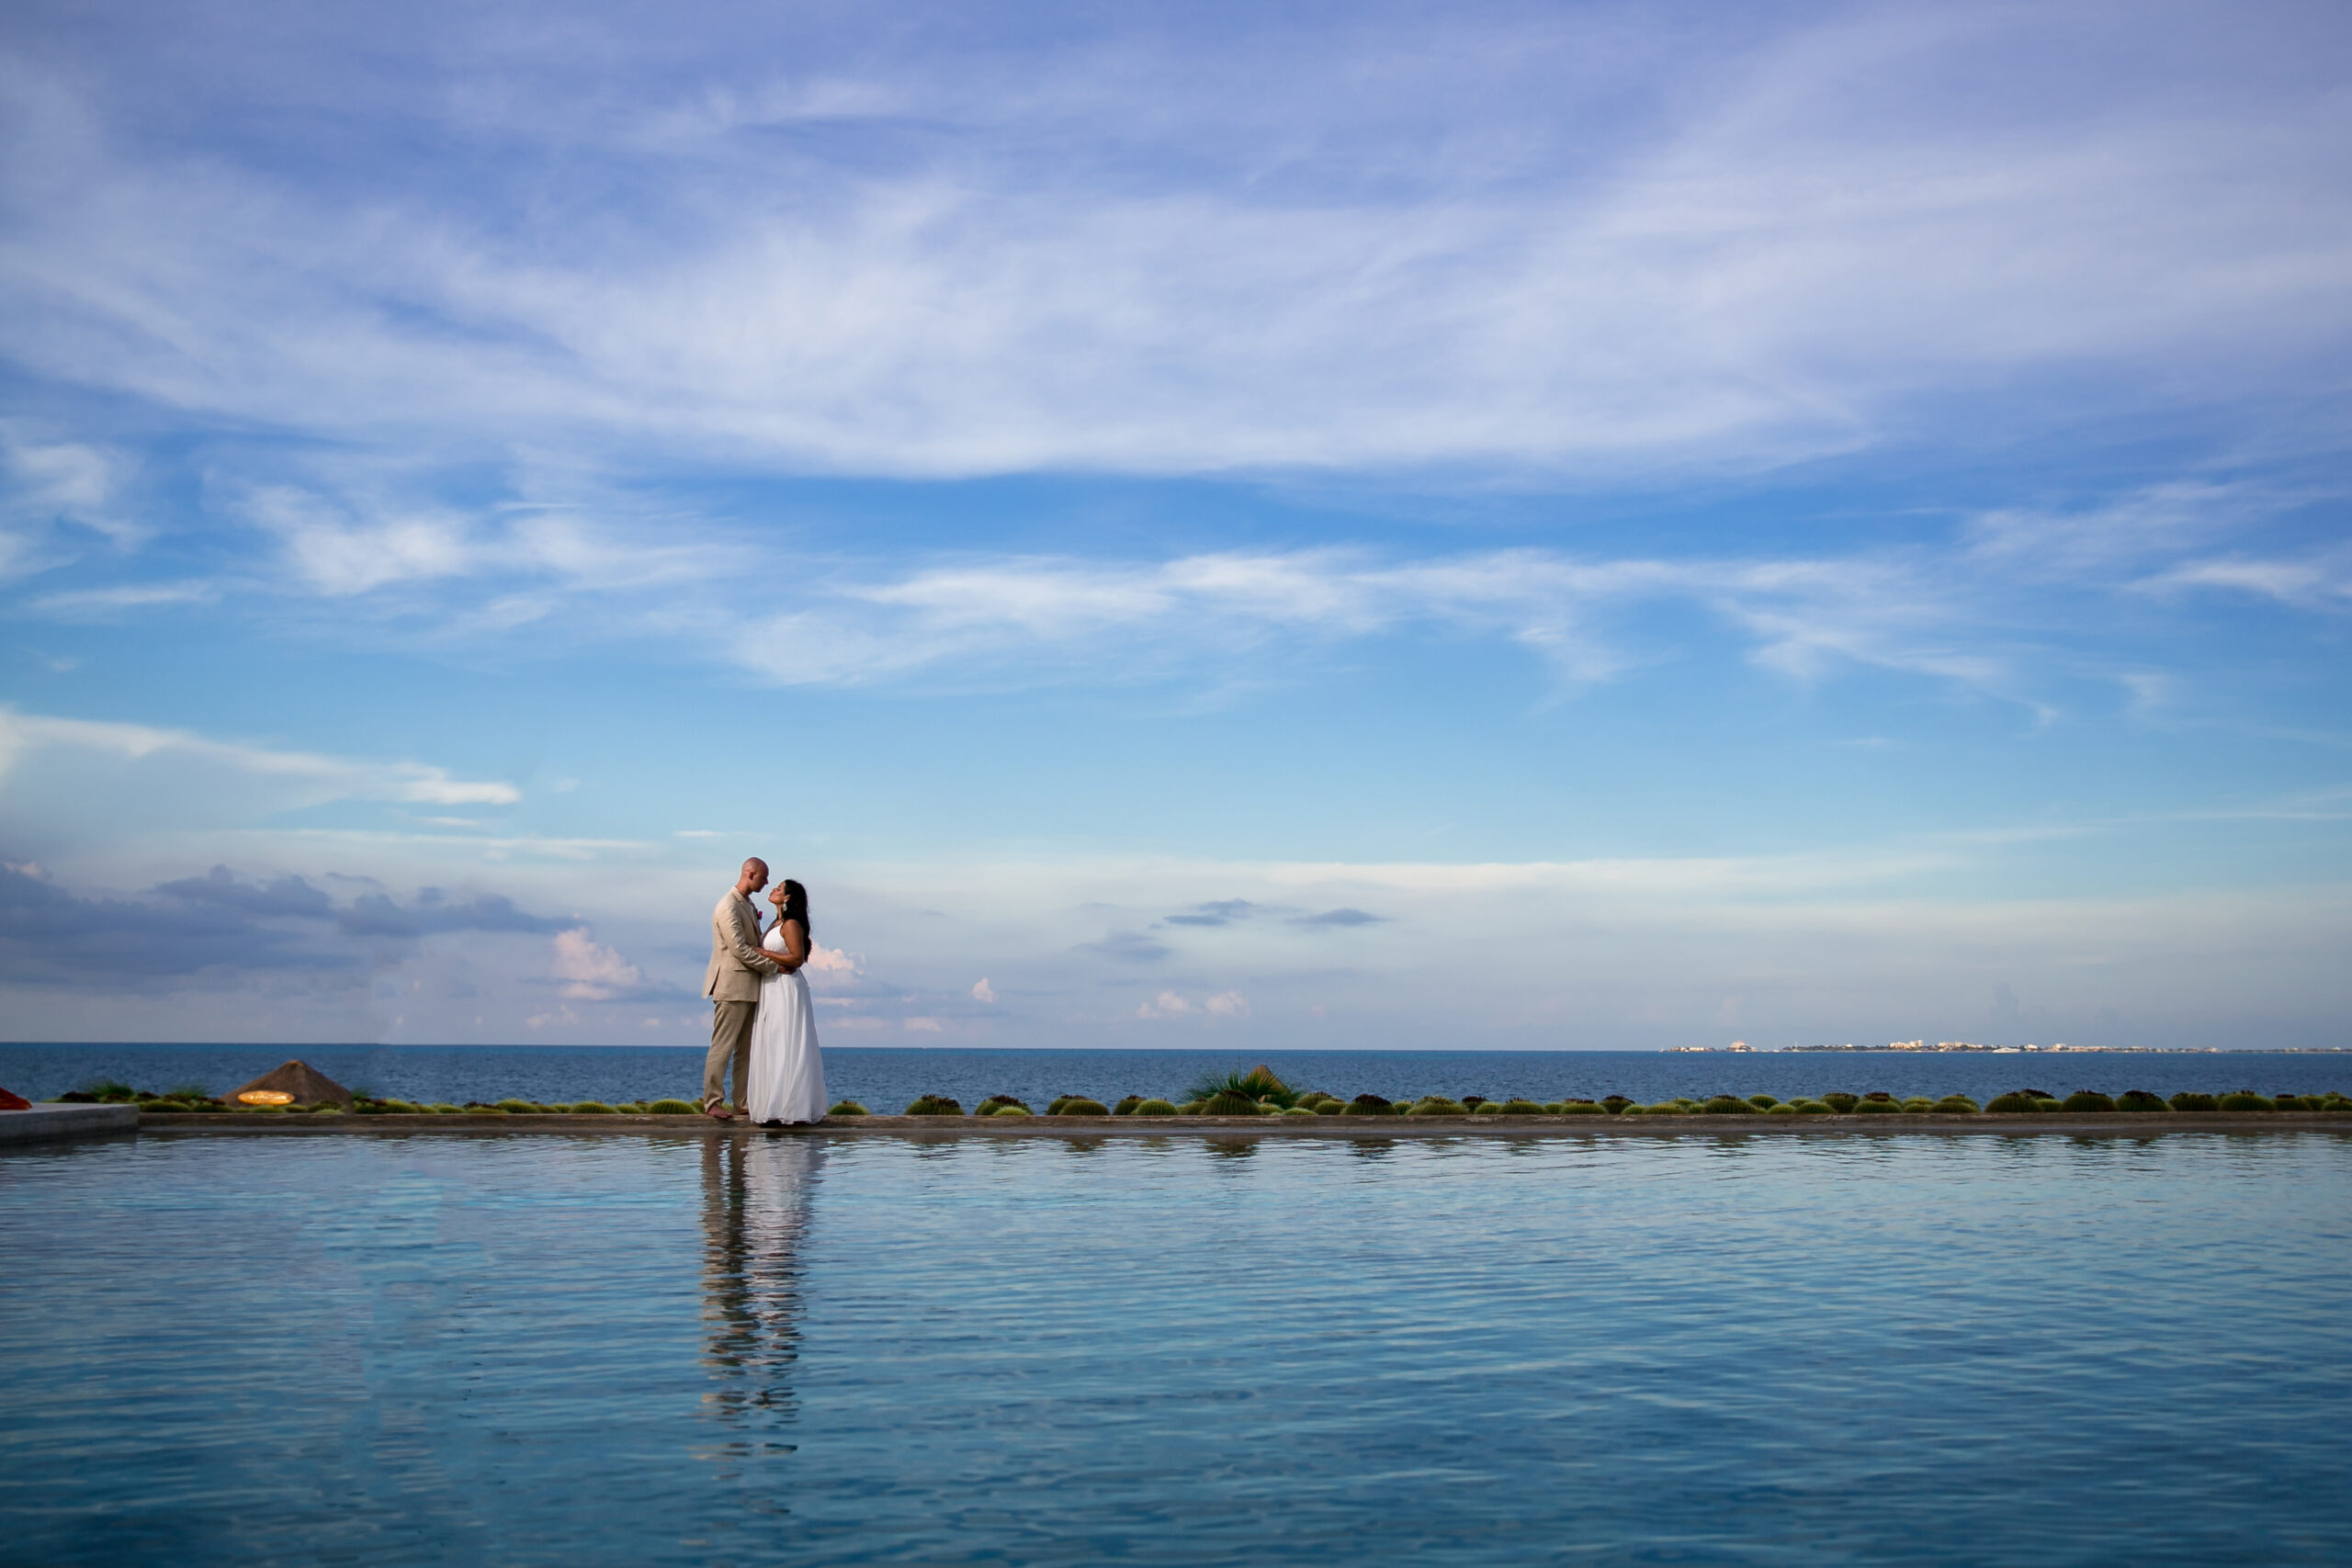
<box><xmin>0</xmin><ymin>1134</ymin><xmax>2352</xmax><ymax>1565</ymax></box>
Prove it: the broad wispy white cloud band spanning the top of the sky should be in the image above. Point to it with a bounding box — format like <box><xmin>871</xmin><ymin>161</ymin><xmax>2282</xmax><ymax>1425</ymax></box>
<box><xmin>0</xmin><ymin>5</ymin><xmax>2352</xmax><ymax>479</ymax></box>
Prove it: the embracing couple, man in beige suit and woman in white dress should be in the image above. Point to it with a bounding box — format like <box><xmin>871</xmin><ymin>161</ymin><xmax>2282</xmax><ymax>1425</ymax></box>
<box><xmin>703</xmin><ymin>861</ymin><xmax>826</xmax><ymax>1126</ymax></box>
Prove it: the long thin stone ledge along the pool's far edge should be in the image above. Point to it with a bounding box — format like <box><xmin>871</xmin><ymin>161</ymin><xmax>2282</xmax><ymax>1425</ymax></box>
<box><xmin>139</xmin><ymin>1110</ymin><xmax>2352</xmax><ymax>1140</ymax></box>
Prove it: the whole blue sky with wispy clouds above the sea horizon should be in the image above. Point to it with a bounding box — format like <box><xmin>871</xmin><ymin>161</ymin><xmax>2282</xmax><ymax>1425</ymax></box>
<box><xmin>0</xmin><ymin>0</ymin><xmax>2352</xmax><ymax>1054</ymax></box>
